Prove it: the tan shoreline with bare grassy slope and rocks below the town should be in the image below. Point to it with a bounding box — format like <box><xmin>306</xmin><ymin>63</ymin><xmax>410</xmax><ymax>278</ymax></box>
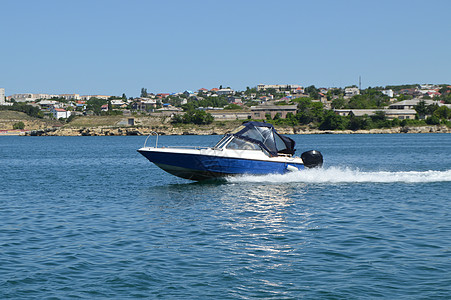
<box><xmin>0</xmin><ymin>111</ymin><xmax>451</xmax><ymax>136</ymax></box>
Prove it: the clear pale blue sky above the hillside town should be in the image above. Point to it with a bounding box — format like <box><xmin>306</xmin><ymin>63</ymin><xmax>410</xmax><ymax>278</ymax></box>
<box><xmin>0</xmin><ymin>0</ymin><xmax>451</xmax><ymax>97</ymax></box>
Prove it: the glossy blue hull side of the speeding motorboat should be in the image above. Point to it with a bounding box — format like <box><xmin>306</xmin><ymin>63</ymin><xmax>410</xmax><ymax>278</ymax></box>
<box><xmin>138</xmin><ymin>150</ymin><xmax>304</xmax><ymax>181</ymax></box>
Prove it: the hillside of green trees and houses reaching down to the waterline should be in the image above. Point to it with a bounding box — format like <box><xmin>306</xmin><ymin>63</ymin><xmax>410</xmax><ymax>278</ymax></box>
<box><xmin>0</xmin><ymin>84</ymin><xmax>451</xmax><ymax>132</ymax></box>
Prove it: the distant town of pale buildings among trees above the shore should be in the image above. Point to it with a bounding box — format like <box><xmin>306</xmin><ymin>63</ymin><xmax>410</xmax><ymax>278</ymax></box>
<box><xmin>0</xmin><ymin>84</ymin><xmax>451</xmax><ymax>130</ymax></box>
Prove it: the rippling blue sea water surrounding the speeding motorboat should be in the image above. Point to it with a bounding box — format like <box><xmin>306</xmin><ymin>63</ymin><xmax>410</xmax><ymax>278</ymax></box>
<box><xmin>0</xmin><ymin>134</ymin><xmax>451</xmax><ymax>299</ymax></box>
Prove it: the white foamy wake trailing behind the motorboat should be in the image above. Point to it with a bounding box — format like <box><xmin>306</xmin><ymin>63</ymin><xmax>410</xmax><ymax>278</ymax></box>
<box><xmin>227</xmin><ymin>167</ymin><xmax>451</xmax><ymax>183</ymax></box>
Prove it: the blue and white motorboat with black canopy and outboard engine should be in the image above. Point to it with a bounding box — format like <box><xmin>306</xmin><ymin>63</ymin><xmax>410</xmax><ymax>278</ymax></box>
<box><xmin>138</xmin><ymin>121</ymin><xmax>323</xmax><ymax>181</ymax></box>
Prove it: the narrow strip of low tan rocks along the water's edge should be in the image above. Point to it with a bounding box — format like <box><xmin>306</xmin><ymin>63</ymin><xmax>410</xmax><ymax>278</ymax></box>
<box><xmin>24</xmin><ymin>126</ymin><xmax>451</xmax><ymax>136</ymax></box>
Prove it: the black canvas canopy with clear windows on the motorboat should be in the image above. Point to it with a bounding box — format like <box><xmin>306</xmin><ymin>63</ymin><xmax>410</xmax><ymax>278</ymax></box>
<box><xmin>232</xmin><ymin>122</ymin><xmax>296</xmax><ymax>156</ymax></box>
